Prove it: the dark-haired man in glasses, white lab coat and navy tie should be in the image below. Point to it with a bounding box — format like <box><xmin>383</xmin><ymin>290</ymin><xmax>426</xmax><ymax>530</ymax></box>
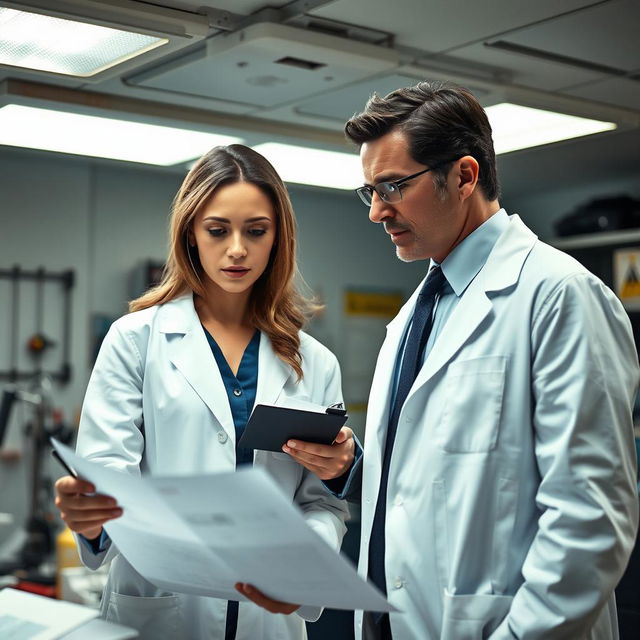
<box><xmin>263</xmin><ymin>83</ymin><xmax>638</xmax><ymax>640</ymax></box>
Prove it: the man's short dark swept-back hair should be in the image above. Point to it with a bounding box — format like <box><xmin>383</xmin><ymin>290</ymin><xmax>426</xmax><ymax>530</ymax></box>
<box><xmin>344</xmin><ymin>82</ymin><xmax>500</xmax><ymax>200</ymax></box>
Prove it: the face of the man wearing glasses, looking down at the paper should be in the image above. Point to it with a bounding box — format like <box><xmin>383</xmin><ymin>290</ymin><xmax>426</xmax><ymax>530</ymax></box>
<box><xmin>360</xmin><ymin>131</ymin><xmax>465</xmax><ymax>262</ymax></box>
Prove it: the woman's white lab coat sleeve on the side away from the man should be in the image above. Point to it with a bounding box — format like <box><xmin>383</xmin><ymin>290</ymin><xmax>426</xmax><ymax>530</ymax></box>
<box><xmin>76</xmin><ymin>316</ymin><xmax>144</xmax><ymax>569</ymax></box>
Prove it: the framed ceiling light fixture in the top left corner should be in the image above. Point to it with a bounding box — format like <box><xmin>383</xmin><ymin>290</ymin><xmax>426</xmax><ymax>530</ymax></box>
<box><xmin>0</xmin><ymin>0</ymin><xmax>210</xmax><ymax>82</ymax></box>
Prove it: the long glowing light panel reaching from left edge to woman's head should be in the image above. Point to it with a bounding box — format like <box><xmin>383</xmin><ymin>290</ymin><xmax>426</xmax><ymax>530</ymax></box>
<box><xmin>0</xmin><ymin>104</ymin><xmax>242</xmax><ymax>166</ymax></box>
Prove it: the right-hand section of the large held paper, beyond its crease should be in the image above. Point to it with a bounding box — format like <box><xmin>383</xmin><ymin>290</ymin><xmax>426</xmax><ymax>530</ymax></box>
<box><xmin>149</xmin><ymin>468</ymin><xmax>393</xmax><ymax>611</ymax></box>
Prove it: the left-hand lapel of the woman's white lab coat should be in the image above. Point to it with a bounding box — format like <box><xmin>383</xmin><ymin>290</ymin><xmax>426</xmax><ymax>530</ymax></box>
<box><xmin>160</xmin><ymin>296</ymin><xmax>235</xmax><ymax>442</ymax></box>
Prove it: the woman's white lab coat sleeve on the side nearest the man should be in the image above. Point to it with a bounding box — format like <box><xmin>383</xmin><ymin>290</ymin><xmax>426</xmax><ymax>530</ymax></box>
<box><xmin>295</xmin><ymin>351</ymin><xmax>349</xmax><ymax>622</ymax></box>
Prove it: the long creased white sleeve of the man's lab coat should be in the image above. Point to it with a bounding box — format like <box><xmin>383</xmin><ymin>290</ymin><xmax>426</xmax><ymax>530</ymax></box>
<box><xmin>490</xmin><ymin>274</ymin><xmax>638</xmax><ymax>640</ymax></box>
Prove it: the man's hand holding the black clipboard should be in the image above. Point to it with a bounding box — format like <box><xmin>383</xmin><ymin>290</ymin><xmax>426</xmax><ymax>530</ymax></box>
<box><xmin>282</xmin><ymin>427</ymin><xmax>355</xmax><ymax>480</ymax></box>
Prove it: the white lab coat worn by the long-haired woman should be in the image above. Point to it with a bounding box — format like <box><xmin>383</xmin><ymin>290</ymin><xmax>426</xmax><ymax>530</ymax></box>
<box><xmin>77</xmin><ymin>295</ymin><xmax>348</xmax><ymax>640</ymax></box>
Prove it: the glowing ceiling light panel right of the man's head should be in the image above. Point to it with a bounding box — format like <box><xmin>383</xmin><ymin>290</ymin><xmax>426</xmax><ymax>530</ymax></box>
<box><xmin>485</xmin><ymin>102</ymin><xmax>617</xmax><ymax>154</ymax></box>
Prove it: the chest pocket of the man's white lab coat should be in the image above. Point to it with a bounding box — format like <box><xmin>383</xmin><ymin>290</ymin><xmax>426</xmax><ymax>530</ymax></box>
<box><xmin>436</xmin><ymin>356</ymin><xmax>507</xmax><ymax>453</ymax></box>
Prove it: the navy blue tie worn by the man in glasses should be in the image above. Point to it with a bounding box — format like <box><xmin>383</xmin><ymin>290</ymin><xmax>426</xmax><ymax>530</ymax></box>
<box><xmin>369</xmin><ymin>266</ymin><xmax>445</xmax><ymax>624</ymax></box>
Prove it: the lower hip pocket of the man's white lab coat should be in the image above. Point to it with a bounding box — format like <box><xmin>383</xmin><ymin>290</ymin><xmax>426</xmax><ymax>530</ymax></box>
<box><xmin>440</xmin><ymin>590</ymin><xmax>513</xmax><ymax>640</ymax></box>
